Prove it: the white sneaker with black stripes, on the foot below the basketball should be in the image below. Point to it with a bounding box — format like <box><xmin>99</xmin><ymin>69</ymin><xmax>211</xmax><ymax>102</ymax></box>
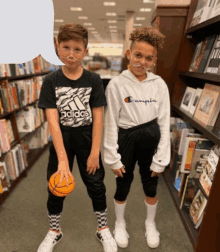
<box><xmin>37</xmin><ymin>230</ymin><xmax>63</xmax><ymax>252</ymax></box>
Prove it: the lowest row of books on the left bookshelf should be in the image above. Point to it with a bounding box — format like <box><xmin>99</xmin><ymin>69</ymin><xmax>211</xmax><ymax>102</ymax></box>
<box><xmin>0</xmin><ymin>122</ymin><xmax>49</xmax><ymax>193</ymax></box>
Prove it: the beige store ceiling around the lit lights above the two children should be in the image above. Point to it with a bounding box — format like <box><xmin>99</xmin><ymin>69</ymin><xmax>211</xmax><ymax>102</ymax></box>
<box><xmin>53</xmin><ymin>0</ymin><xmax>155</xmax><ymax>43</ymax></box>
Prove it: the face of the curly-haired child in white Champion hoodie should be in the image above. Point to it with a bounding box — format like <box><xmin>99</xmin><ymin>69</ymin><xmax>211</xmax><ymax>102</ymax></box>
<box><xmin>126</xmin><ymin>41</ymin><xmax>157</xmax><ymax>80</ymax></box>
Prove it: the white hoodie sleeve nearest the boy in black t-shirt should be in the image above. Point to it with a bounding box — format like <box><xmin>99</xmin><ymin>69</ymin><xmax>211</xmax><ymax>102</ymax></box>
<box><xmin>102</xmin><ymin>81</ymin><xmax>123</xmax><ymax>169</ymax></box>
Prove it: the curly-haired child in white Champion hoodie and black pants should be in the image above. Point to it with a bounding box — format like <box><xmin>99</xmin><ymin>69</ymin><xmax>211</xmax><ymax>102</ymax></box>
<box><xmin>102</xmin><ymin>27</ymin><xmax>170</xmax><ymax>248</ymax></box>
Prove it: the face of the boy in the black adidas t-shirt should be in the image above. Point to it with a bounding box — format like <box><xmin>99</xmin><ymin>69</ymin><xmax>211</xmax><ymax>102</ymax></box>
<box><xmin>58</xmin><ymin>40</ymin><xmax>88</xmax><ymax>70</ymax></box>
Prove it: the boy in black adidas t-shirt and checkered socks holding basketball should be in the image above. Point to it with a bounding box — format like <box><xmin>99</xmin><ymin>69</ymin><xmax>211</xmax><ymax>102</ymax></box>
<box><xmin>38</xmin><ymin>24</ymin><xmax>117</xmax><ymax>252</ymax></box>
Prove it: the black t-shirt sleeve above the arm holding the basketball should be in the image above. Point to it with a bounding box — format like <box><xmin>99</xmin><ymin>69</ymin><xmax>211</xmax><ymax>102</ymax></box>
<box><xmin>38</xmin><ymin>78</ymin><xmax>57</xmax><ymax>109</ymax></box>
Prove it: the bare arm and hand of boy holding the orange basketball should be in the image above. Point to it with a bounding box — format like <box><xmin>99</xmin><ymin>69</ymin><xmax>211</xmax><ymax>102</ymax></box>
<box><xmin>46</xmin><ymin>108</ymin><xmax>73</xmax><ymax>182</ymax></box>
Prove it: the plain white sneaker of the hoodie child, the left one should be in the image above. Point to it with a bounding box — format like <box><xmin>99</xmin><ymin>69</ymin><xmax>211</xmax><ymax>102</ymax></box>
<box><xmin>113</xmin><ymin>222</ymin><xmax>129</xmax><ymax>248</ymax></box>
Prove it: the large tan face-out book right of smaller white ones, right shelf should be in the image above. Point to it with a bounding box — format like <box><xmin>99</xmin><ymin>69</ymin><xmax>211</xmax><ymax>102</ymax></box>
<box><xmin>194</xmin><ymin>83</ymin><xmax>220</xmax><ymax>125</ymax></box>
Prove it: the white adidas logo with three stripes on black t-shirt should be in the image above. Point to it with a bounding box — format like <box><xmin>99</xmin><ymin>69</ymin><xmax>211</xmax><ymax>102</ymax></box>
<box><xmin>61</xmin><ymin>96</ymin><xmax>89</xmax><ymax>118</ymax></box>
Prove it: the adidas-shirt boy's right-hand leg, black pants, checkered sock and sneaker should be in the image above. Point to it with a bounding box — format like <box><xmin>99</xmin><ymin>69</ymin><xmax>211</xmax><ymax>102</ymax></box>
<box><xmin>75</xmin><ymin>129</ymin><xmax>117</xmax><ymax>252</ymax></box>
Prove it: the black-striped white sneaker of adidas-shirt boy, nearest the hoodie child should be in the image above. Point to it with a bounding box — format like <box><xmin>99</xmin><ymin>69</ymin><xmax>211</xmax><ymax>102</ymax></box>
<box><xmin>96</xmin><ymin>228</ymin><xmax>118</xmax><ymax>252</ymax></box>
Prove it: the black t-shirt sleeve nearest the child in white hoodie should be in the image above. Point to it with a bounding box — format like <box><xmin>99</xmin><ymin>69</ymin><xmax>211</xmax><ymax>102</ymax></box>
<box><xmin>90</xmin><ymin>74</ymin><xmax>107</xmax><ymax>108</ymax></box>
